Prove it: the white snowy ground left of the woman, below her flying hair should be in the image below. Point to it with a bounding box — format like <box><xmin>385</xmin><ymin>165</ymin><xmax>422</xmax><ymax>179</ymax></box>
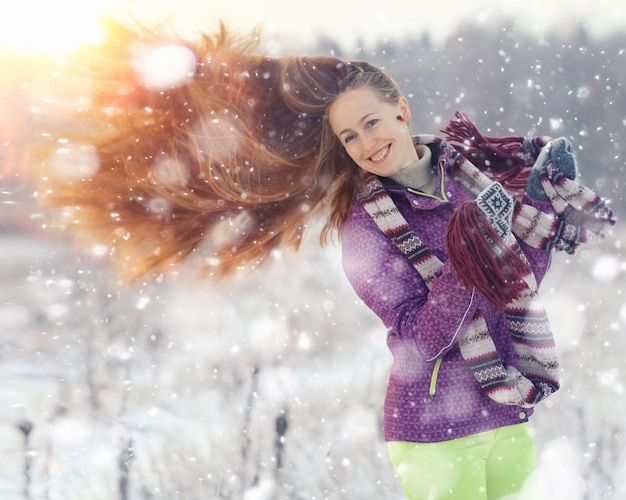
<box><xmin>0</xmin><ymin>231</ymin><xmax>399</xmax><ymax>500</ymax></box>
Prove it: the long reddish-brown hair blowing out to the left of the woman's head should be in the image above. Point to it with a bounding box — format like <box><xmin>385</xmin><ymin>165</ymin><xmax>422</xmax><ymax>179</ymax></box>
<box><xmin>45</xmin><ymin>21</ymin><xmax>400</xmax><ymax>281</ymax></box>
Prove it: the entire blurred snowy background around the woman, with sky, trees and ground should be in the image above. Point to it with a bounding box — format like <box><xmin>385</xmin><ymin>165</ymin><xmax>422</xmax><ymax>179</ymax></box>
<box><xmin>0</xmin><ymin>0</ymin><xmax>626</xmax><ymax>500</ymax></box>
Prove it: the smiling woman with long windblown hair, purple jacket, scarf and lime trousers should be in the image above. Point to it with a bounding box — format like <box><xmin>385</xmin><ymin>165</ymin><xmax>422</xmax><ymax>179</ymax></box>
<box><xmin>41</xmin><ymin>22</ymin><xmax>614</xmax><ymax>499</ymax></box>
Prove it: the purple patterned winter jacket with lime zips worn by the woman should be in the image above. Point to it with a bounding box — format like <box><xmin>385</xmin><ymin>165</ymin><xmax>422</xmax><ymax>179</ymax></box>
<box><xmin>342</xmin><ymin>152</ymin><xmax>550</xmax><ymax>442</ymax></box>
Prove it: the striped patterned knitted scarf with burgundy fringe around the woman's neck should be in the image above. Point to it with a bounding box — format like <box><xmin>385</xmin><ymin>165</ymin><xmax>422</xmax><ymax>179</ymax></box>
<box><xmin>358</xmin><ymin>114</ymin><xmax>615</xmax><ymax>407</ymax></box>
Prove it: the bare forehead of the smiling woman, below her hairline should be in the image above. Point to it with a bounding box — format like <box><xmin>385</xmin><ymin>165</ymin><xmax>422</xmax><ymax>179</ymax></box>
<box><xmin>328</xmin><ymin>87</ymin><xmax>390</xmax><ymax>133</ymax></box>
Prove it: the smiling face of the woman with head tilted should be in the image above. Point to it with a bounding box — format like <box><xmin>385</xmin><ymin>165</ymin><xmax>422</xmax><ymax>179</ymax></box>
<box><xmin>328</xmin><ymin>87</ymin><xmax>418</xmax><ymax>177</ymax></box>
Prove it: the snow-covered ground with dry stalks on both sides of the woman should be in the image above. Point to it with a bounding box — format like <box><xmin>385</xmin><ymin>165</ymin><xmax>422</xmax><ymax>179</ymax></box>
<box><xmin>0</xmin><ymin>220</ymin><xmax>626</xmax><ymax>500</ymax></box>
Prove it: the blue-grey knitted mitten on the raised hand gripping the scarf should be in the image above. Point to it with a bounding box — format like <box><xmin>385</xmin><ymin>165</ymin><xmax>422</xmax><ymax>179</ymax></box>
<box><xmin>526</xmin><ymin>137</ymin><xmax>578</xmax><ymax>201</ymax></box>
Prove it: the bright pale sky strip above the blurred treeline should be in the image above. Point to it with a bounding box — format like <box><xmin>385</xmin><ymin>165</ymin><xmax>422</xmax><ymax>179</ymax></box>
<box><xmin>0</xmin><ymin>0</ymin><xmax>626</xmax><ymax>52</ymax></box>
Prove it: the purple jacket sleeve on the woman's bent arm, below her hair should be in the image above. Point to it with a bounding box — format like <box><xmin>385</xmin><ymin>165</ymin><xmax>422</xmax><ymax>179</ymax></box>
<box><xmin>342</xmin><ymin>205</ymin><xmax>484</xmax><ymax>360</ymax></box>
